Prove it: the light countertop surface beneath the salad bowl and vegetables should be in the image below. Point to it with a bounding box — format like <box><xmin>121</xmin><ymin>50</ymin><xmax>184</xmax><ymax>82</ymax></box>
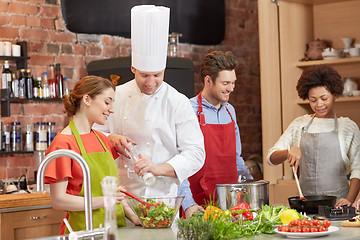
<box><xmin>118</xmin><ymin>221</ymin><xmax>360</xmax><ymax>240</ymax></box>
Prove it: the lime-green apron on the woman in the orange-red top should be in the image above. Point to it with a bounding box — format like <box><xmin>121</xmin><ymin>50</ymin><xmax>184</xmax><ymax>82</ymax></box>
<box><xmin>65</xmin><ymin>120</ymin><xmax>126</xmax><ymax>233</ymax></box>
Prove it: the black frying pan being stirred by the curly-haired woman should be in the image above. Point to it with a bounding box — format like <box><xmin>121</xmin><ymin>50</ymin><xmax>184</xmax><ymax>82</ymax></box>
<box><xmin>288</xmin><ymin>196</ymin><xmax>336</xmax><ymax>214</ymax></box>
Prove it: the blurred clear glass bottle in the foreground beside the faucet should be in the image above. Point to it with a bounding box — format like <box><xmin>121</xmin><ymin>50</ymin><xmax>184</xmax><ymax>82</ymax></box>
<box><xmin>101</xmin><ymin>176</ymin><xmax>119</xmax><ymax>240</ymax></box>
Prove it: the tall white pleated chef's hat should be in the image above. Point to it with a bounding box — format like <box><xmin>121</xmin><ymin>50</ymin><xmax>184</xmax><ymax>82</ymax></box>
<box><xmin>131</xmin><ymin>5</ymin><xmax>170</xmax><ymax>72</ymax></box>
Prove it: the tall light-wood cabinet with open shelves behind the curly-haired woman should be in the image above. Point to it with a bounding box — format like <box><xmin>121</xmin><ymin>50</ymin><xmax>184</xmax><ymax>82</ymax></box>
<box><xmin>258</xmin><ymin>0</ymin><xmax>360</xmax><ymax>203</ymax></box>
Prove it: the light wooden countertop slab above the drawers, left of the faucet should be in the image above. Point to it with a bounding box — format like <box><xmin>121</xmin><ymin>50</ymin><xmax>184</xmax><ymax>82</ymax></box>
<box><xmin>0</xmin><ymin>193</ymin><xmax>51</xmax><ymax>208</ymax></box>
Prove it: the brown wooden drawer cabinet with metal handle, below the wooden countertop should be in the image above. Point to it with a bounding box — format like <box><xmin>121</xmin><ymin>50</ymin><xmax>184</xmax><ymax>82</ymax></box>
<box><xmin>0</xmin><ymin>208</ymin><xmax>65</xmax><ymax>240</ymax></box>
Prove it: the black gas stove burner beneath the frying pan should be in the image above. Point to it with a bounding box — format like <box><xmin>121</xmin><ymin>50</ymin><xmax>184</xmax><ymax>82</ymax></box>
<box><xmin>314</xmin><ymin>205</ymin><xmax>356</xmax><ymax>221</ymax></box>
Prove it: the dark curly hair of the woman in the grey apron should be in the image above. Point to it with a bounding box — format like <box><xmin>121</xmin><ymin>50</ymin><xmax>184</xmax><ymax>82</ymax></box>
<box><xmin>296</xmin><ymin>64</ymin><xmax>344</xmax><ymax>100</ymax></box>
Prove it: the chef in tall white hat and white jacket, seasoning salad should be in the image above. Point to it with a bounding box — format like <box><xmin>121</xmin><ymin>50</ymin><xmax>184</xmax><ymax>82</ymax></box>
<box><xmin>95</xmin><ymin>5</ymin><xmax>205</xmax><ymax>197</ymax></box>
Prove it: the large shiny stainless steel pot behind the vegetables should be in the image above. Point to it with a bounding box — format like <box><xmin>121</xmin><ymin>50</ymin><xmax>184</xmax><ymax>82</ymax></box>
<box><xmin>216</xmin><ymin>180</ymin><xmax>269</xmax><ymax>210</ymax></box>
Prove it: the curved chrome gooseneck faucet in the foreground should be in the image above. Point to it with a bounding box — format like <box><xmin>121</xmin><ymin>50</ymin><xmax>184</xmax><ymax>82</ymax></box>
<box><xmin>36</xmin><ymin>149</ymin><xmax>93</xmax><ymax>231</ymax></box>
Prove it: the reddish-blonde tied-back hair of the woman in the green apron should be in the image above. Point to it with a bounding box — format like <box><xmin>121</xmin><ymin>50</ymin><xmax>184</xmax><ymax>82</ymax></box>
<box><xmin>63</xmin><ymin>75</ymin><xmax>115</xmax><ymax>115</ymax></box>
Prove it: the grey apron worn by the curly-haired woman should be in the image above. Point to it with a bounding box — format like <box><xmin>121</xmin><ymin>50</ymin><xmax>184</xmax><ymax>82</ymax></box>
<box><xmin>299</xmin><ymin>115</ymin><xmax>349</xmax><ymax>200</ymax></box>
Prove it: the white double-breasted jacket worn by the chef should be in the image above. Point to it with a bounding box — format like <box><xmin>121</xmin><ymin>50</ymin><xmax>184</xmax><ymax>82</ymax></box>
<box><xmin>94</xmin><ymin>80</ymin><xmax>205</xmax><ymax>197</ymax></box>
